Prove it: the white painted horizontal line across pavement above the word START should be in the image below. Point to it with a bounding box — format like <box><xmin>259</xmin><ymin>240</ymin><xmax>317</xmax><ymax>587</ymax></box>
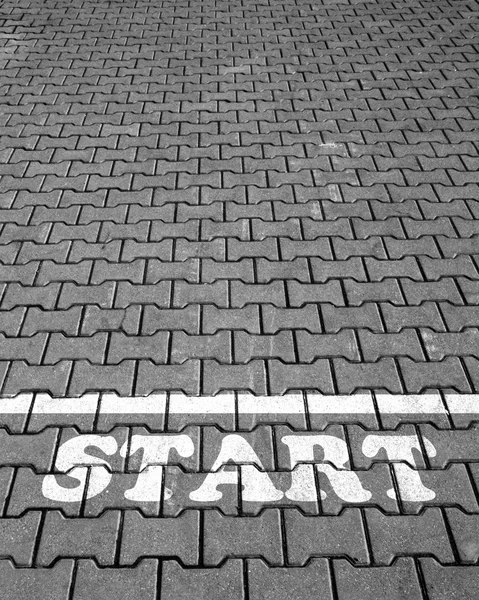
<box><xmin>0</xmin><ymin>392</ymin><xmax>479</xmax><ymax>416</ymax></box>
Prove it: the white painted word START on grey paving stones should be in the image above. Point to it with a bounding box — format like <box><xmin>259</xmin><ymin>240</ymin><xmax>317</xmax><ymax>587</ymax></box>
<box><xmin>42</xmin><ymin>434</ymin><xmax>436</xmax><ymax>505</ymax></box>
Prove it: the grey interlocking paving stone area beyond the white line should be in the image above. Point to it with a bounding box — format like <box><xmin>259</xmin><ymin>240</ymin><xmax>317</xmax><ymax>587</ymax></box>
<box><xmin>0</xmin><ymin>0</ymin><xmax>479</xmax><ymax>396</ymax></box>
